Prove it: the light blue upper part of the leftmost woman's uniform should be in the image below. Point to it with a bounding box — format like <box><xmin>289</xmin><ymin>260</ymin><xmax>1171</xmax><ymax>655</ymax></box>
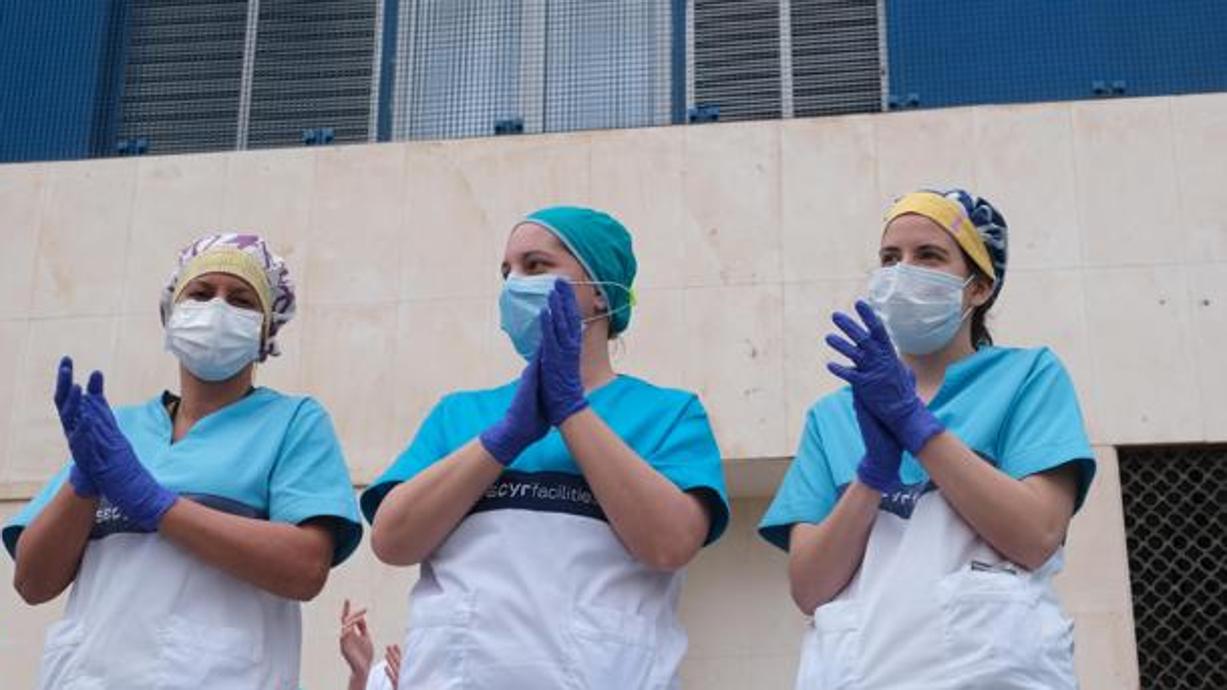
<box><xmin>2</xmin><ymin>388</ymin><xmax>362</xmax><ymax>566</ymax></box>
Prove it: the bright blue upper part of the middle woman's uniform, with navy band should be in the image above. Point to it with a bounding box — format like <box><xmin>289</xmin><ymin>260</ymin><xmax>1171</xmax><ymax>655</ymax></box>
<box><xmin>362</xmin><ymin>376</ymin><xmax>729</xmax><ymax>544</ymax></box>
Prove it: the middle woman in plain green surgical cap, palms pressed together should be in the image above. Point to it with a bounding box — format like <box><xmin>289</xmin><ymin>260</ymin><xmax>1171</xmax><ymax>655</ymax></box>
<box><xmin>362</xmin><ymin>206</ymin><xmax>729</xmax><ymax>690</ymax></box>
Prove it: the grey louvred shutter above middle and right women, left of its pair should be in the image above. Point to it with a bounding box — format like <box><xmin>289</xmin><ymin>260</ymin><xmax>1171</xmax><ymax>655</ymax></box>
<box><xmin>693</xmin><ymin>0</ymin><xmax>783</xmax><ymax>120</ymax></box>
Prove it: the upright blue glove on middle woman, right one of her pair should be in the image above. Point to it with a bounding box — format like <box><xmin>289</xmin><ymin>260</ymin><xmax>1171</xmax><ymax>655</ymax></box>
<box><xmin>541</xmin><ymin>280</ymin><xmax>588</xmax><ymax>426</ymax></box>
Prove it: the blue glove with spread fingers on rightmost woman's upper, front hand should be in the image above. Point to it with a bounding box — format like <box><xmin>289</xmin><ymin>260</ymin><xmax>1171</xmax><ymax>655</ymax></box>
<box><xmin>827</xmin><ymin>300</ymin><xmax>945</xmax><ymax>455</ymax></box>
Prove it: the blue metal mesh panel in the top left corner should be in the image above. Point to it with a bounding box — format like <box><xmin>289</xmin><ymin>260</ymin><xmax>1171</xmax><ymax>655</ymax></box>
<box><xmin>0</xmin><ymin>0</ymin><xmax>115</xmax><ymax>162</ymax></box>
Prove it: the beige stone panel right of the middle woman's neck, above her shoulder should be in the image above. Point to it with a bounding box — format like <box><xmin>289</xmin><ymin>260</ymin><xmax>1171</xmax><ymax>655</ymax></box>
<box><xmin>610</xmin><ymin>289</ymin><xmax>692</xmax><ymax>392</ymax></box>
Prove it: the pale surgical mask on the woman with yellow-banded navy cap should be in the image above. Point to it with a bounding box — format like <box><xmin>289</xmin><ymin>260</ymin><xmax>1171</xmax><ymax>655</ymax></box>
<box><xmin>869</xmin><ymin>264</ymin><xmax>972</xmax><ymax>355</ymax></box>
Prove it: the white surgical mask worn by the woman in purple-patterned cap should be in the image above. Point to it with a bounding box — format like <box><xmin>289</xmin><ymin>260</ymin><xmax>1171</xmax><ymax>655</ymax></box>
<box><xmin>166</xmin><ymin>297</ymin><xmax>264</xmax><ymax>381</ymax></box>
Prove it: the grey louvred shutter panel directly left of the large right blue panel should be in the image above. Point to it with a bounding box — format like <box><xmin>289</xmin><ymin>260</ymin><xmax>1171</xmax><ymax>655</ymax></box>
<box><xmin>791</xmin><ymin>0</ymin><xmax>882</xmax><ymax>117</ymax></box>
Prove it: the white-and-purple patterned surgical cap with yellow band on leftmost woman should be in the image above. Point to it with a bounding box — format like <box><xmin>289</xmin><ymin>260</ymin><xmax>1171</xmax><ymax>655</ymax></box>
<box><xmin>160</xmin><ymin>232</ymin><xmax>294</xmax><ymax>362</ymax></box>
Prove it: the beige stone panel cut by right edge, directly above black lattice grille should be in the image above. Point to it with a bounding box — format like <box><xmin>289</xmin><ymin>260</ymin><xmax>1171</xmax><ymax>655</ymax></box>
<box><xmin>1182</xmin><ymin>262</ymin><xmax>1227</xmax><ymax>443</ymax></box>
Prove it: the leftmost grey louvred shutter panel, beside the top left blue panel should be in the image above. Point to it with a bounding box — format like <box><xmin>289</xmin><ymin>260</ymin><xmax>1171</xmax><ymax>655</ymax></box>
<box><xmin>118</xmin><ymin>0</ymin><xmax>247</xmax><ymax>153</ymax></box>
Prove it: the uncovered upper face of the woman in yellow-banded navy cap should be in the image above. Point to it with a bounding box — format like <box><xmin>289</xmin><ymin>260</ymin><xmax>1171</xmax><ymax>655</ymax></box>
<box><xmin>877</xmin><ymin>214</ymin><xmax>993</xmax><ymax>308</ymax></box>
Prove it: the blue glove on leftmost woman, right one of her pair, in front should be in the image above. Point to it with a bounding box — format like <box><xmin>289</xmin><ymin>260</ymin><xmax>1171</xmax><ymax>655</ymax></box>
<box><xmin>77</xmin><ymin>372</ymin><xmax>179</xmax><ymax>532</ymax></box>
